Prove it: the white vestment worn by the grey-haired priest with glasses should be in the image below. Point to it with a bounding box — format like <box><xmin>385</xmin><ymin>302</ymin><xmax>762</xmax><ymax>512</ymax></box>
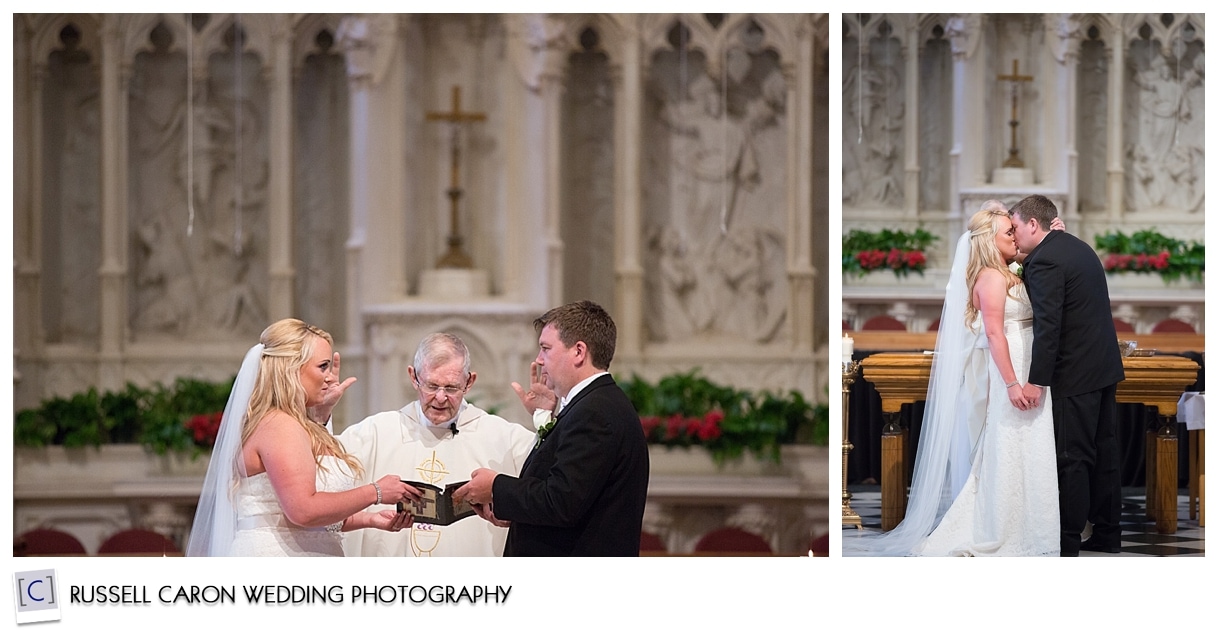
<box><xmin>339</xmin><ymin>401</ymin><xmax>536</xmax><ymax>557</ymax></box>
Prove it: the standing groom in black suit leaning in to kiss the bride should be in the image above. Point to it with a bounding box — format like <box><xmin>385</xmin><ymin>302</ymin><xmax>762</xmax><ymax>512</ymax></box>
<box><xmin>1011</xmin><ymin>195</ymin><xmax>1125</xmax><ymax>557</ymax></box>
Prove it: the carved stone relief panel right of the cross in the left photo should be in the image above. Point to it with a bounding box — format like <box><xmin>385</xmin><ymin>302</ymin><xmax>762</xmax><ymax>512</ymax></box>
<box><xmin>646</xmin><ymin>56</ymin><xmax>787</xmax><ymax>342</ymax></box>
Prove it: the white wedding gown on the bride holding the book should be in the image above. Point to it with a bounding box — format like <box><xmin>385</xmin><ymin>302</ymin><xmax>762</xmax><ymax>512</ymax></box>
<box><xmin>230</xmin><ymin>456</ymin><xmax>356</xmax><ymax>557</ymax></box>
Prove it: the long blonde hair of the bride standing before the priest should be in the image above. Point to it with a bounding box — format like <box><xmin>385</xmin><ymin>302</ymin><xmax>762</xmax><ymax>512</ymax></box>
<box><xmin>241</xmin><ymin>318</ymin><xmax>363</xmax><ymax>475</ymax></box>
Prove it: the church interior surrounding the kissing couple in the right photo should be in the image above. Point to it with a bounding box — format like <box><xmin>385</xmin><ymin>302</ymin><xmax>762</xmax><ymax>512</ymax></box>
<box><xmin>834</xmin><ymin>13</ymin><xmax>1206</xmax><ymax>555</ymax></box>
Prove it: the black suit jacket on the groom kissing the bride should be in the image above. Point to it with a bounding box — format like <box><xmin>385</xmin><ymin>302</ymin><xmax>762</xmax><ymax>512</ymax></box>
<box><xmin>1023</xmin><ymin>230</ymin><xmax>1125</xmax><ymax>397</ymax></box>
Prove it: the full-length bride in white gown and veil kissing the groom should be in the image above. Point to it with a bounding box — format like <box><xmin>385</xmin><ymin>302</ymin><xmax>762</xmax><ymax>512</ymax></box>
<box><xmin>842</xmin><ymin>200</ymin><xmax>1060</xmax><ymax>557</ymax></box>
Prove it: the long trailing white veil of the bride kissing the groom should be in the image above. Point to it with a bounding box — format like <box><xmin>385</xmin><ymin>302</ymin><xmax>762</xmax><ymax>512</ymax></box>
<box><xmin>842</xmin><ymin>235</ymin><xmax>985</xmax><ymax>557</ymax></box>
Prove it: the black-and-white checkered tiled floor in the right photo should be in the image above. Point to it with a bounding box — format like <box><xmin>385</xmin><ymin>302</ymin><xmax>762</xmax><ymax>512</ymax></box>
<box><xmin>842</xmin><ymin>486</ymin><xmax>1206</xmax><ymax>557</ymax></box>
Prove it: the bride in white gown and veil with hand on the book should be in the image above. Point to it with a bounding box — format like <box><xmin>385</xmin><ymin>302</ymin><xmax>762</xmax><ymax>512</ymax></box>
<box><xmin>186</xmin><ymin>318</ymin><xmax>419</xmax><ymax>557</ymax></box>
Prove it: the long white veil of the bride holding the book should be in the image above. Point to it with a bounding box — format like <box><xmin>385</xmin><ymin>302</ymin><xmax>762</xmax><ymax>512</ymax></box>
<box><xmin>186</xmin><ymin>344</ymin><xmax>262</xmax><ymax>557</ymax></box>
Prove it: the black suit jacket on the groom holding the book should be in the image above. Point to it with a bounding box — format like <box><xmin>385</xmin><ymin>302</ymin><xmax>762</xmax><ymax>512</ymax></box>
<box><xmin>492</xmin><ymin>374</ymin><xmax>650</xmax><ymax>557</ymax></box>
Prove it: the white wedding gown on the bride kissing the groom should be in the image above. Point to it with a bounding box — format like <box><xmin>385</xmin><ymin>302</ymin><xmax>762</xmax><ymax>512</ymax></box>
<box><xmin>914</xmin><ymin>284</ymin><xmax>1061</xmax><ymax>557</ymax></box>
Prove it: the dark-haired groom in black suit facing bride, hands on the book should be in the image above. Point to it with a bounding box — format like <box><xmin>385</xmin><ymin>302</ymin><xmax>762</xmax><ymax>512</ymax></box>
<box><xmin>453</xmin><ymin>301</ymin><xmax>650</xmax><ymax>557</ymax></box>
